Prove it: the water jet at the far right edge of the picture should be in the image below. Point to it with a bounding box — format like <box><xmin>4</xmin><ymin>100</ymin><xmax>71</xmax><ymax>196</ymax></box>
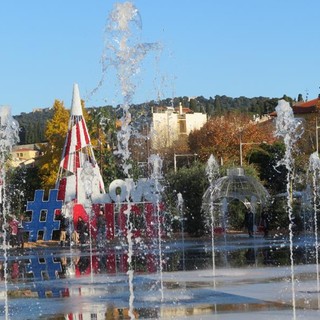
<box><xmin>309</xmin><ymin>152</ymin><xmax>320</xmax><ymax>309</ymax></box>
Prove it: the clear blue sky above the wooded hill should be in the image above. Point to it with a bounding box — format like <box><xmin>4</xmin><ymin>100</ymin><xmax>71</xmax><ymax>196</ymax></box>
<box><xmin>0</xmin><ymin>0</ymin><xmax>320</xmax><ymax>115</ymax></box>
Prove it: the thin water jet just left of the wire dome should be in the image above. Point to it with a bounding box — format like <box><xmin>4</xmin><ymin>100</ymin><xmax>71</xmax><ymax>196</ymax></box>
<box><xmin>206</xmin><ymin>155</ymin><xmax>219</xmax><ymax>288</ymax></box>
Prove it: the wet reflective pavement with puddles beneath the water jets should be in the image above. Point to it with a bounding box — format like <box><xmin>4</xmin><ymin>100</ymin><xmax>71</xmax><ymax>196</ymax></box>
<box><xmin>0</xmin><ymin>235</ymin><xmax>320</xmax><ymax>320</ymax></box>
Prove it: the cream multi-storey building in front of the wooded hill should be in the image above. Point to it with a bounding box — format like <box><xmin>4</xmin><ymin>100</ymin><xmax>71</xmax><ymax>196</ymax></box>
<box><xmin>151</xmin><ymin>102</ymin><xmax>207</xmax><ymax>149</ymax></box>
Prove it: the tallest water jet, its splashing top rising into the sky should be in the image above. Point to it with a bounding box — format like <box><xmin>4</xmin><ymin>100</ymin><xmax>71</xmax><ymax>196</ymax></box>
<box><xmin>99</xmin><ymin>2</ymin><xmax>159</xmax><ymax>319</ymax></box>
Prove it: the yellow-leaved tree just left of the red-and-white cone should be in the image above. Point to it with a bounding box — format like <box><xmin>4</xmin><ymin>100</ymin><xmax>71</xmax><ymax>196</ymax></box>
<box><xmin>39</xmin><ymin>100</ymin><xmax>70</xmax><ymax>190</ymax></box>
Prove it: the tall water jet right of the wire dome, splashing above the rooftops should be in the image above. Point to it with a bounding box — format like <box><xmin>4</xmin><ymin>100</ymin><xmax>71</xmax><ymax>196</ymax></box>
<box><xmin>275</xmin><ymin>100</ymin><xmax>303</xmax><ymax>319</ymax></box>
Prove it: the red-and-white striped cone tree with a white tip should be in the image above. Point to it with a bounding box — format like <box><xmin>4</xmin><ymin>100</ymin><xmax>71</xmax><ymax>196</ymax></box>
<box><xmin>56</xmin><ymin>84</ymin><xmax>105</xmax><ymax>204</ymax></box>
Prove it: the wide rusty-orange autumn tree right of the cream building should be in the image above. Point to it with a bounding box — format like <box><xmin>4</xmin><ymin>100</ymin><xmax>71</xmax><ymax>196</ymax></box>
<box><xmin>189</xmin><ymin>112</ymin><xmax>275</xmax><ymax>164</ymax></box>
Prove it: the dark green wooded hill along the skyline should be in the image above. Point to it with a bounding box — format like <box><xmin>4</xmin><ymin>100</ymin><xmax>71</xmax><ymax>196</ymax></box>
<box><xmin>14</xmin><ymin>95</ymin><xmax>293</xmax><ymax>144</ymax></box>
